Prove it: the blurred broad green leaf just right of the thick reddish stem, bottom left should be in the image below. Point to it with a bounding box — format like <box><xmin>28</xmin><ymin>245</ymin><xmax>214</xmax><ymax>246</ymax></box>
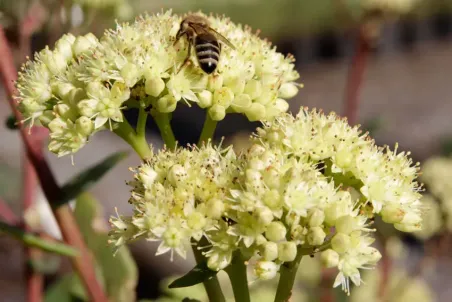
<box><xmin>74</xmin><ymin>193</ymin><xmax>138</xmax><ymax>302</ymax></box>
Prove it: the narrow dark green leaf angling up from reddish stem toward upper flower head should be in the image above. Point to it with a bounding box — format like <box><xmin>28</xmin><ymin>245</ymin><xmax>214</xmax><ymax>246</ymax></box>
<box><xmin>56</xmin><ymin>152</ymin><xmax>128</xmax><ymax>207</ymax></box>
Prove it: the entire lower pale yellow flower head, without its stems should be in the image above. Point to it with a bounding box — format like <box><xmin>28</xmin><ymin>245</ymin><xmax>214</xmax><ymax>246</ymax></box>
<box><xmin>111</xmin><ymin>109</ymin><xmax>421</xmax><ymax>291</ymax></box>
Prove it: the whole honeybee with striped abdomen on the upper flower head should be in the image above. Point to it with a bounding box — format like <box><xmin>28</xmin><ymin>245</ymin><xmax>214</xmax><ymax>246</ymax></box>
<box><xmin>174</xmin><ymin>14</ymin><xmax>235</xmax><ymax>74</ymax></box>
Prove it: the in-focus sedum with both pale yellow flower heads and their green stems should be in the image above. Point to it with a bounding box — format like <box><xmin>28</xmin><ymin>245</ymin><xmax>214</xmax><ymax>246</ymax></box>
<box><xmin>17</xmin><ymin>12</ymin><xmax>421</xmax><ymax>301</ymax></box>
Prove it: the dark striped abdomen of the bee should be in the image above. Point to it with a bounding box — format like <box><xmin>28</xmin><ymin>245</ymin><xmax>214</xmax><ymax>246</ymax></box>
<box><xmin>195</xmin><ymin>34</ymin><xmax>220</xmax><ymax>74</ymax></box>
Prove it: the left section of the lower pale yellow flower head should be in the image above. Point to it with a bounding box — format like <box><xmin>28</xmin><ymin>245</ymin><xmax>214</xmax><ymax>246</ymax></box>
<box><xmin>110</xmin><ymin>145</ymin><xmax>238</xmax><ymax>265</ymax></box>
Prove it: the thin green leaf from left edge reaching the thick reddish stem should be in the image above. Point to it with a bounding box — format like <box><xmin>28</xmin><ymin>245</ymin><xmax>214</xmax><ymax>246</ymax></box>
<box><xmin>0</xmin><ymin>221</ymin><xmax>77</xmax><ymax>257</ymax></box>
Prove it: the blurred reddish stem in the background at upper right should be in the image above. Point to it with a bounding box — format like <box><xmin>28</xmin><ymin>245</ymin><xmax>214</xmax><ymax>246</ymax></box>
<box><xmin>344</xmin><ymin>29</ymin><xmax>370</xmax><ymax>125</ymax></box>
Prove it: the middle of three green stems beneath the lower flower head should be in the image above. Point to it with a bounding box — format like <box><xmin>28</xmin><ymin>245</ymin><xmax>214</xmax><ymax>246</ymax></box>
<box><xmin>225</xmin><ymin>252</ymin><xmax>250</xmax><ymax>302</ymax></box>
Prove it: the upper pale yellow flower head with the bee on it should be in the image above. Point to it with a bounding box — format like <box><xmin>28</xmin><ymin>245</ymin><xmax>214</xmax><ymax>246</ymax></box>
<box><xmin>17</xmin><ymin>12</ymin><xmax>299</xmax><ymax>156</ymax></box>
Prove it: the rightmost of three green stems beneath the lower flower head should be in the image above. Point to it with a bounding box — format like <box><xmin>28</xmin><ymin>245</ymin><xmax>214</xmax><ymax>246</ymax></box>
<box><xmin>275</xmin><ymin>247</ymin><xmax>304</xmax><ymax>302</ymax></box>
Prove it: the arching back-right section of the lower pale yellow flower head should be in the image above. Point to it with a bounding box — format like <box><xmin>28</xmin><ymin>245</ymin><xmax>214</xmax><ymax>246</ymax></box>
<box><xmin>255</xmin><ymin>109</ymin><xmax>421</xmax><ymax>232</ymax></box>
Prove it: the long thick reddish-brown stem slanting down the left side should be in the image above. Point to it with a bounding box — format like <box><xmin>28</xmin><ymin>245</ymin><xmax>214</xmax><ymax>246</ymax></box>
<box><xmin>0</xmin><ymin>27</ymin><xmax>108</xmax><ymax>302</ymax></box>
